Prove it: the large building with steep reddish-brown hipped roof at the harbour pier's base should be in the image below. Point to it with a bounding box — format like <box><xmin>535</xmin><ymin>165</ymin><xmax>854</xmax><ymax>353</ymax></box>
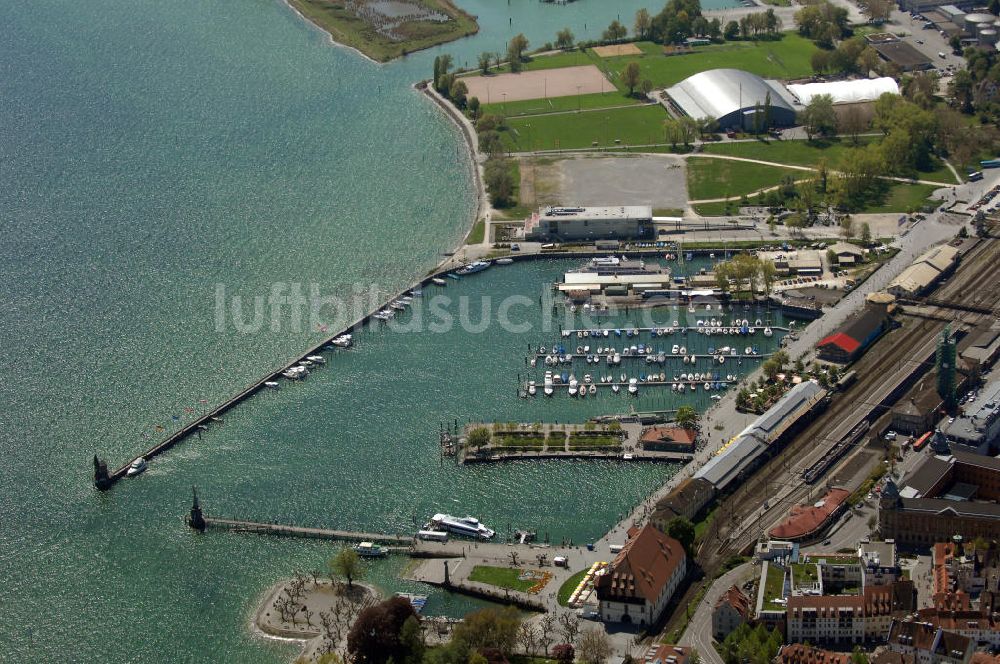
<box><xmin>594</xmin><ymin>523</ymin><xmax>687</xmax><ymax>625</ymax></box>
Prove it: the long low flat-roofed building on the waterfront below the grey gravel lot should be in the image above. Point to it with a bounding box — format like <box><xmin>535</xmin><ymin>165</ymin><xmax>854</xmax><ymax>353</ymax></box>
<box><xmin>524</xmin><ymin>205</ymin><xmax>653</xmax><ymax>242</ymax></box>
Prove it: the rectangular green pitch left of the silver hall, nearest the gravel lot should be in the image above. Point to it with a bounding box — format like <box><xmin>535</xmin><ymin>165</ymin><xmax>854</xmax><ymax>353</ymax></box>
<box><xmin>501</xmin><ymin>105</ymin><xmax>667</xmax><ymax>152</ymax></box>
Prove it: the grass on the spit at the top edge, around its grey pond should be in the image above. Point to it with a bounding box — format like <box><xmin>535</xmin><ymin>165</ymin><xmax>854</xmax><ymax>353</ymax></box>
<box><xmin>291</xmin><ymin>0</ymin><xmax>479</xmax><ymax>62</ymax></box>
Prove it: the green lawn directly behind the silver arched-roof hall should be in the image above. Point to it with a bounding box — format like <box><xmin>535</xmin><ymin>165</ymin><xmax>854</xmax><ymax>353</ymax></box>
<box><xmin>588</xmin><ymin>32</ymin><xmax>817</xmax><ymax>88</ymax></box>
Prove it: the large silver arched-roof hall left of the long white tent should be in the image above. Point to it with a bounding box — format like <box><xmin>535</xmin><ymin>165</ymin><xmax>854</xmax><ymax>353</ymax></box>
<box><xmin>667</xmin><ymin>69</ymin><xmax>795</xmax><ymax>129</ymax></box>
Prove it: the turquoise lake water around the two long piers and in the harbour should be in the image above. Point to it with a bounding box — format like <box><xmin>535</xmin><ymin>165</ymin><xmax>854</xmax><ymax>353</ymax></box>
<box><xmin>0</xmin><ymin>0</ymin><xmax>744</xmax><ymax>662</ymax></box>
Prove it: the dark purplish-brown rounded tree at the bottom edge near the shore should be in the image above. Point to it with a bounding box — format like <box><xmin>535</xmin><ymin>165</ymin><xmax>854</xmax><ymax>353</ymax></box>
<box><xmin>347</xmin><ymin>597</ymin><xmax>419</xmax><ymax>664</ymax></box>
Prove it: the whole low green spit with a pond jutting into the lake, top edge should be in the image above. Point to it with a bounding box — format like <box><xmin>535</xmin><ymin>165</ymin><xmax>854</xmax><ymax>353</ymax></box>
<box><xmin>288</xmin><ymin>0</ymin><xmax>479</xmax><ymax>62</ymax></box>
